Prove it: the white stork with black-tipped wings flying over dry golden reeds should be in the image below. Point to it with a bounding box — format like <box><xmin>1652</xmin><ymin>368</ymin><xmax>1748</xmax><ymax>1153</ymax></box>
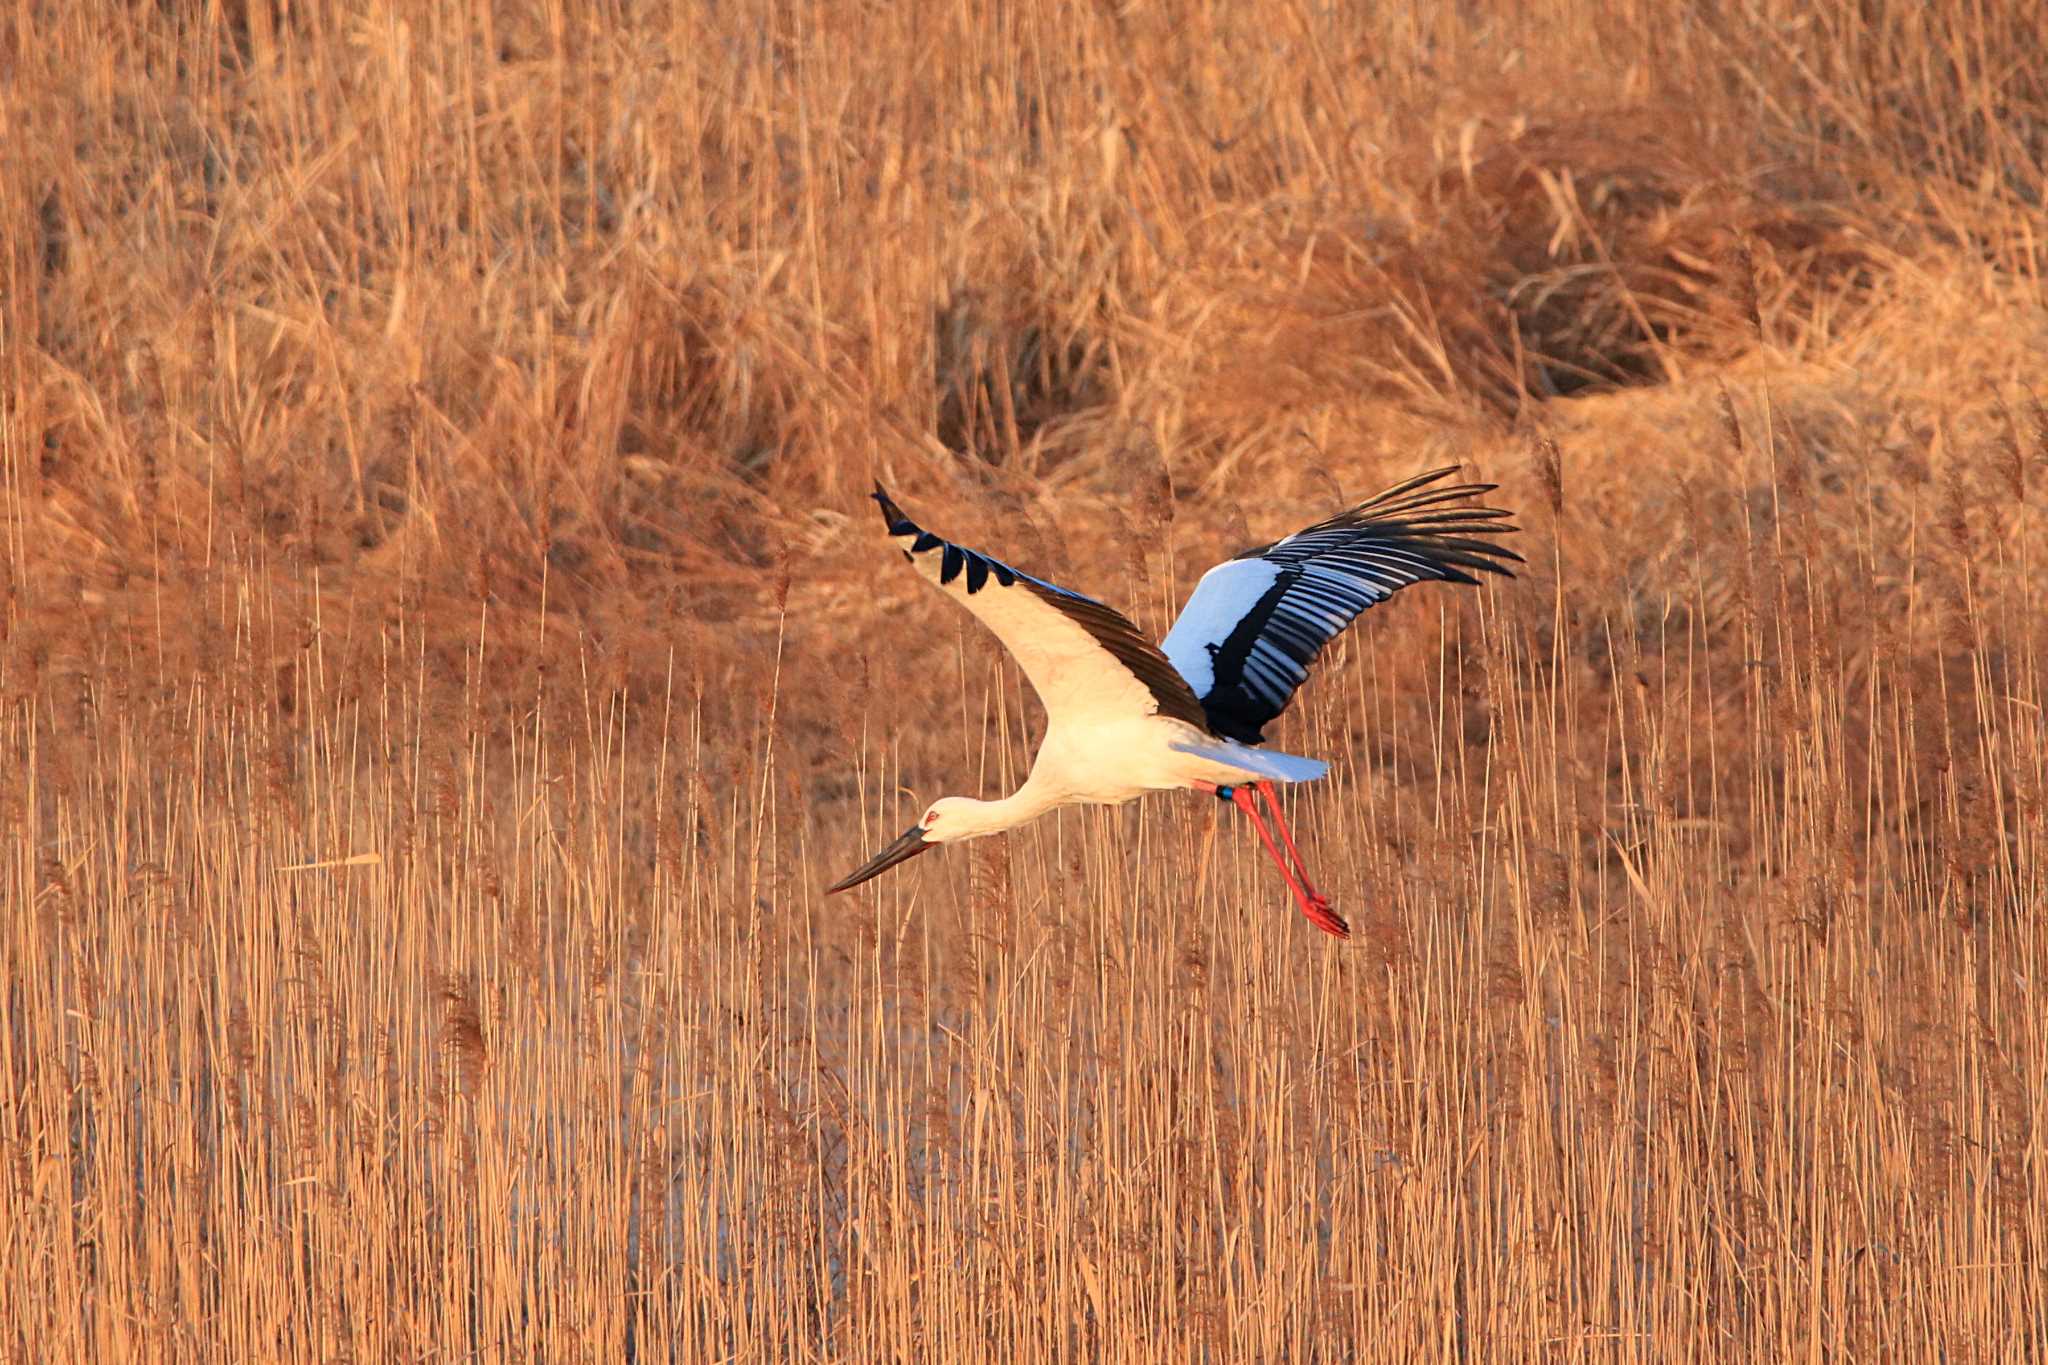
<box><xmin>827</xmin><ymin>469</ymin><xmax>1522</xmax><ymax>937</ymax></box>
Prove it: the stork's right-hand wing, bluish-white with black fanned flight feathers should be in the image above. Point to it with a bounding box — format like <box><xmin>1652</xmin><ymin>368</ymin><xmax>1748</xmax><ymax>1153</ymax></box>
<box><xmin>1161</xmin><ymin>469</ymin><xmax>1522</xmax><ymax>745</ymax></box>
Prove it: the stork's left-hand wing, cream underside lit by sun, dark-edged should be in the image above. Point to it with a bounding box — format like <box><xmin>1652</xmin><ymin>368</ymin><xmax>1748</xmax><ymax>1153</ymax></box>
<box><xmin>874</xmin><ymin>483</ymin><xmax>1206</xmax><ymax>729</ymax></box>
